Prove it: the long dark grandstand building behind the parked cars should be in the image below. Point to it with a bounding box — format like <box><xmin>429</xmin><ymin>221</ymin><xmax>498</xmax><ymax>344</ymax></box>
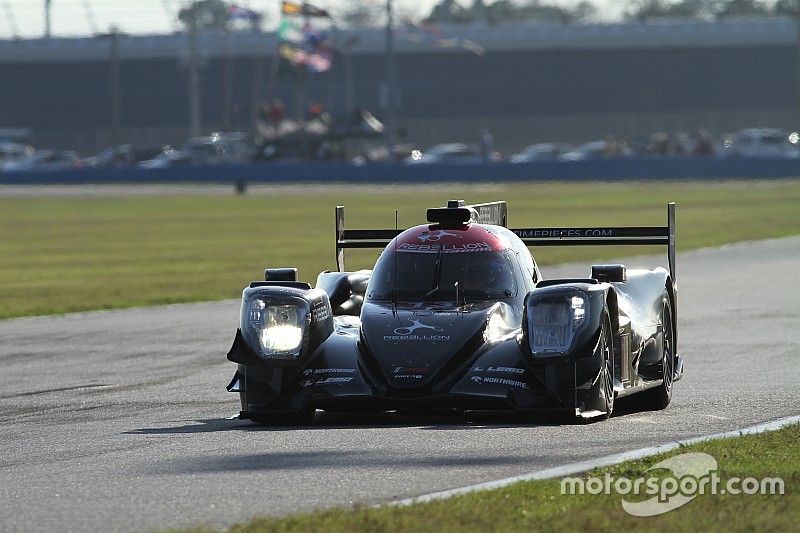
<box><xmin>0</xmin><ymin>17</ymin><xmax>800</xmax><ymax>155</ymax></box>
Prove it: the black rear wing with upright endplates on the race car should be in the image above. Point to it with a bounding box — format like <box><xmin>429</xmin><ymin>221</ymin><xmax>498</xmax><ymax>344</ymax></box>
<box><xmin>336</xmin><ymin>200</ymin><xmax>675</xmax><ymax>280</ymax></box>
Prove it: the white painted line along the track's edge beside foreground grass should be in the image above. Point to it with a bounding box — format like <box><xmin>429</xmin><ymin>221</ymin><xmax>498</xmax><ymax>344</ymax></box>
<box><xmin>388</xmin><ymin>416</ymin><xmax>800</xmax><ymax>507</ymax></box>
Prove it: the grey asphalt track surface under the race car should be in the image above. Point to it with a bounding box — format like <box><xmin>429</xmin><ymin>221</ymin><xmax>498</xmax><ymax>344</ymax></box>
<box><xmin>0</xmin><ymin>237</ymin><xmax>800</xmax><ymax>532</ymax></box>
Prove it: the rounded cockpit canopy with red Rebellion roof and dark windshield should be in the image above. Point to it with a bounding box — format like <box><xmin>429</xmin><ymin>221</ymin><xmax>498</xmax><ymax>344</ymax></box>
<box><xmin>366</xmin><ymin>225</ymin><xmax>519</xmax><ymax>301</ymax></box>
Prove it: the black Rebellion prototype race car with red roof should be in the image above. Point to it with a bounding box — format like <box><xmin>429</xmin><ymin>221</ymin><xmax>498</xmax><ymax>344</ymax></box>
<box><xmin>227</xmin><ymin>200</ymin><xmax>683</xmax><ymax>424</ymax></box>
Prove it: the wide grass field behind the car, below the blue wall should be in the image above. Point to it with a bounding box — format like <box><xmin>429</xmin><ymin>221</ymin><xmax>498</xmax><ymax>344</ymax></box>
<box><xmin>0</xmin><ymin>179</ymin><xmax>800</xmax><ymax>318</ymax></box>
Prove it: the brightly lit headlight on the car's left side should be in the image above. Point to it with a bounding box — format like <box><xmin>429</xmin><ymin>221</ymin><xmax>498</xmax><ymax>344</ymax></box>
<box><xmin>247</xmin><ymin>298</ymin><xmax>308</xmax><ymax>359</ymax></box>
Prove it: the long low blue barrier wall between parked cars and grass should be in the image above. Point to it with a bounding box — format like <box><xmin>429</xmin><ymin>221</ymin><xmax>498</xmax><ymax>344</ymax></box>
<box><xmin>0</xmin><ymin>156</ymin><xmax>800</xmax><ymax>188</ymax></box>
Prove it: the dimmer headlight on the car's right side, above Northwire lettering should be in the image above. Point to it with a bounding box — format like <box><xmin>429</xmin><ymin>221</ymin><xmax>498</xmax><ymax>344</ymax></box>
<box><xmin>528</xmin><ymin>294</ymin><xmax>588</xmax><ymax>353</ymax></box>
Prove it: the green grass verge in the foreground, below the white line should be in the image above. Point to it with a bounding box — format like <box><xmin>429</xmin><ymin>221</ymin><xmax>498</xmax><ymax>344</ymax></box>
<box><xmin>184</xmin><ymin>424</ymin><xmax>800</xmax><ymax>533</ymax></box>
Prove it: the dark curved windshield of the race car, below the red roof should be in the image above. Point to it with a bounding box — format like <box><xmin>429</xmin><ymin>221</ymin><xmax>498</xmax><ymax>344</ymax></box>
<box><xmin>367</xmin><ymin>250</ymin><xmax>517</xmax><ymax>301</ymax></box>
